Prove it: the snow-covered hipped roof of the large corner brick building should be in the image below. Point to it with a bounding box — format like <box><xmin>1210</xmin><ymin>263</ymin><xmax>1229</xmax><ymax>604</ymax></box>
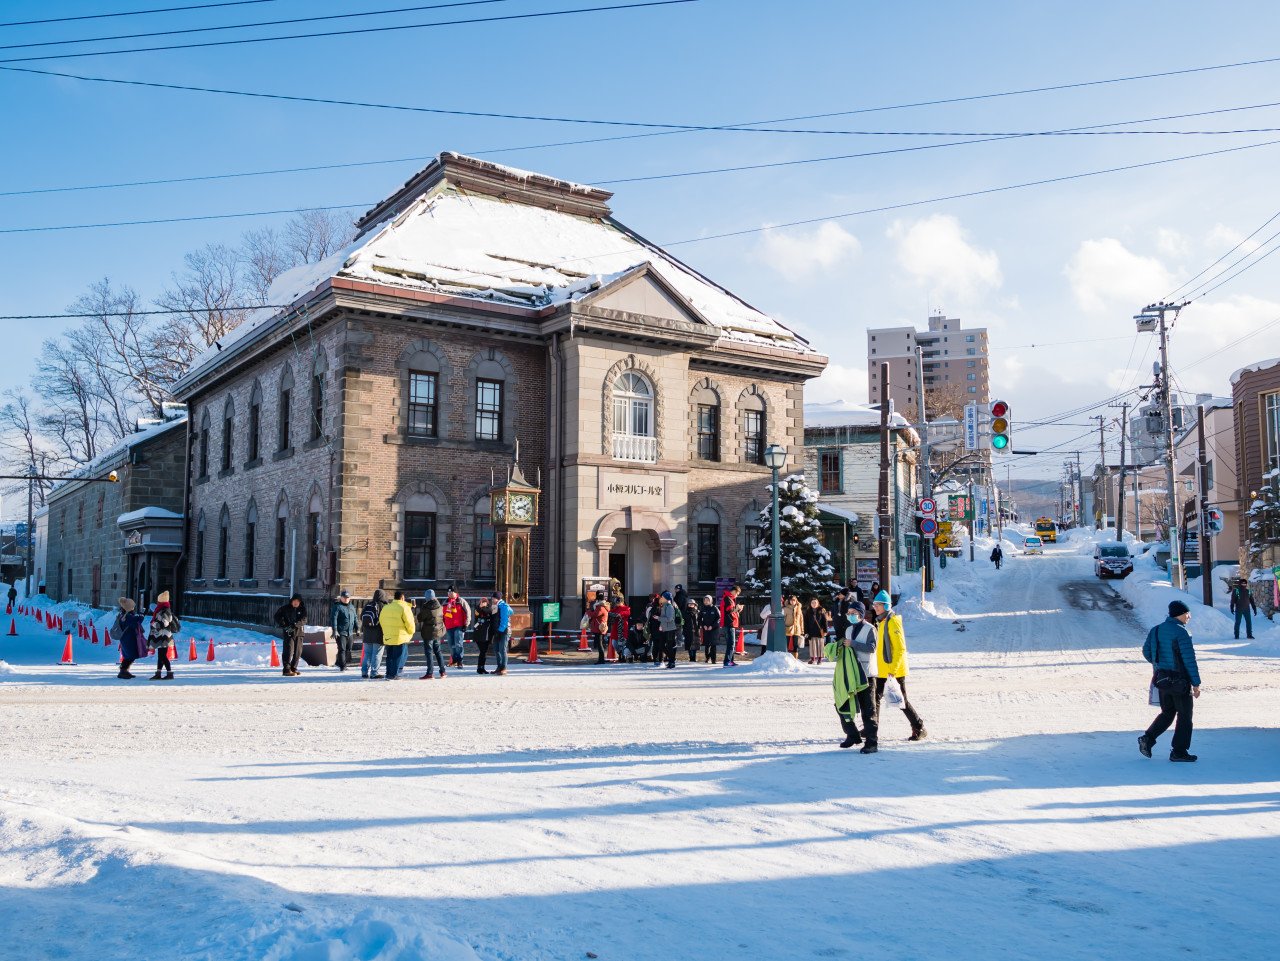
<box><xmin>177</xmin><ymin>154</ymin><xmax>817</xmax><ymax>380</ymax></box>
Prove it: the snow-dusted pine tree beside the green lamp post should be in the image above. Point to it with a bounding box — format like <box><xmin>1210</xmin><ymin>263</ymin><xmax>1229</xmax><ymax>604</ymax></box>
<box><xmin>746</xmin><ymin>473</ymin><xmax>837</xmax><ymax>595</ymax></box>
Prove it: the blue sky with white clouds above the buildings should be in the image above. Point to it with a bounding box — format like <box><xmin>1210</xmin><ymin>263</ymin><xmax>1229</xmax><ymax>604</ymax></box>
<box><xmin>0</xmin><ymin>0</ymin><xmax>1280</xmax><ymax>476</ymax></box>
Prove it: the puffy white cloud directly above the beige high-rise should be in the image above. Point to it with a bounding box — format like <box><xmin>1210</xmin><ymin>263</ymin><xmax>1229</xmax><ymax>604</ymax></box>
<box><xmin>887</xmin><ymin>214</ymin><xmax>1004</xmax><ymax>301</ymax></box>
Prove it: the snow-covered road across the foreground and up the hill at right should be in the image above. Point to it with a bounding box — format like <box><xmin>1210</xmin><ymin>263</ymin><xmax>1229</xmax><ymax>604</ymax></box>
<box><xmin>0</xmin><ymin>545</ymin><xmax>1280</xmax><ymax>961</ymax></box>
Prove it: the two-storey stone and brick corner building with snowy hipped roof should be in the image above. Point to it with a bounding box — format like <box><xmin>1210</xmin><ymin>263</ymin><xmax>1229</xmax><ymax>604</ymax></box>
<box><xmin>175</xmin><ymin>154</ymin><xmax>826</xmax><ymax>623</ymax></box>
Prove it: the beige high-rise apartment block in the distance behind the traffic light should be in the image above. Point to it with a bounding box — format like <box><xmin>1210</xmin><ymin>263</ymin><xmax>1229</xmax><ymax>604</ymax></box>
<box><xmin>867</xmin><ymin>314</ymin><xmax>991</xmax><ymax>409</ymax></box>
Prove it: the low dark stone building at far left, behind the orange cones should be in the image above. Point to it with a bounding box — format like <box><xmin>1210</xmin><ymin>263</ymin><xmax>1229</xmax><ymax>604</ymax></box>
<box><xmin>37</xmin><ymin>418</ymin><xmax>187</xmax><ymax>607</ymax></box>
